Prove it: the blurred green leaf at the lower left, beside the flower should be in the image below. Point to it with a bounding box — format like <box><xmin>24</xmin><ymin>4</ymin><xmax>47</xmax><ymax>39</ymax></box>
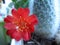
<box><xmin>0</xmin><ymin>22</ymin><xmax>7</xmax><ymax>45</ymax></box>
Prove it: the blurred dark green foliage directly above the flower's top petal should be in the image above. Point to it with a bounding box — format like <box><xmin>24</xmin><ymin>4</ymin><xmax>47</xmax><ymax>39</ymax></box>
<box><xmin>13</xmin><ymin>0</ymin><xmax>28</xmax><ymax>9</ymax></box>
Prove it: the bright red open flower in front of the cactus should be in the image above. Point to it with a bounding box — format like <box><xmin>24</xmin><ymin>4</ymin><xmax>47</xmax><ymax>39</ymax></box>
<box><xmin>4</xmin><ymin>8</ymin><xmax>38</xmax><ymax>41</ymax></box>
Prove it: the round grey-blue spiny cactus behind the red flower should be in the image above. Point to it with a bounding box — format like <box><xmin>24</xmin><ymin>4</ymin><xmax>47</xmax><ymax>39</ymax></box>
<box><xmin>33</xmin><ymin>0</ymin><xmax>59</xmax><ymax>38</ymax></box>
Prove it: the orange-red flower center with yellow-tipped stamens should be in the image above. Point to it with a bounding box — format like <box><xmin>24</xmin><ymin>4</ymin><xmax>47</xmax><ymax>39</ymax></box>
<box><xmin>15</xmin><ymin>18</ymin><xmax>29</xmax><ymax>32</ymax></box>
